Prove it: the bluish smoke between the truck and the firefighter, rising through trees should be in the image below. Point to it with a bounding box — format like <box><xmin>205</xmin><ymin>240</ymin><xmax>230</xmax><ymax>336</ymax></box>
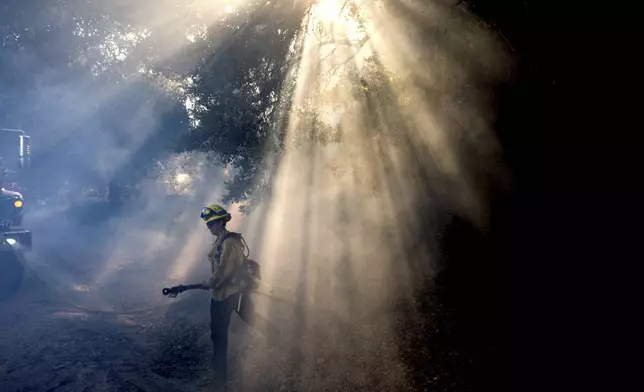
<box><xmin>0</xmin><ymin>1</ymin><xmax>229</xmax><ymax>310</ymax></box>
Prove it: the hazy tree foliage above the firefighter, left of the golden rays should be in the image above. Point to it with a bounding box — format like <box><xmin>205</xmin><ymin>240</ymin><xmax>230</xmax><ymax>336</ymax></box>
<box><xmin>0</xmin><ymin>0</ymin><xmax>328</xmax><ymax>207</ymax></box>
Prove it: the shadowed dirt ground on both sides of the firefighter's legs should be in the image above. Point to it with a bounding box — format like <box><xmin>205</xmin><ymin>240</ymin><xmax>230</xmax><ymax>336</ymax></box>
<box><xmin>0</xmin><ymin>260</ymin><xmax>428</xmax><ymax>392</ymax></box>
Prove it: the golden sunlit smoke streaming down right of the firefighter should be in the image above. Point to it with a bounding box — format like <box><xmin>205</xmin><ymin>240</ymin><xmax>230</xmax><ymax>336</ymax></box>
<box><xmin>221</xmin><ymin>1</ymin><xmax>511</xmax><ymax>390</ymax></box>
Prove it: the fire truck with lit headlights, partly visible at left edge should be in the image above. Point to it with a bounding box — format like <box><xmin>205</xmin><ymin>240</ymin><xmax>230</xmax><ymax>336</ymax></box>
<box><xmin>0</xmin><ymin>128</ymin><xmax>31</xmax><ymax>298</ymax></box>
